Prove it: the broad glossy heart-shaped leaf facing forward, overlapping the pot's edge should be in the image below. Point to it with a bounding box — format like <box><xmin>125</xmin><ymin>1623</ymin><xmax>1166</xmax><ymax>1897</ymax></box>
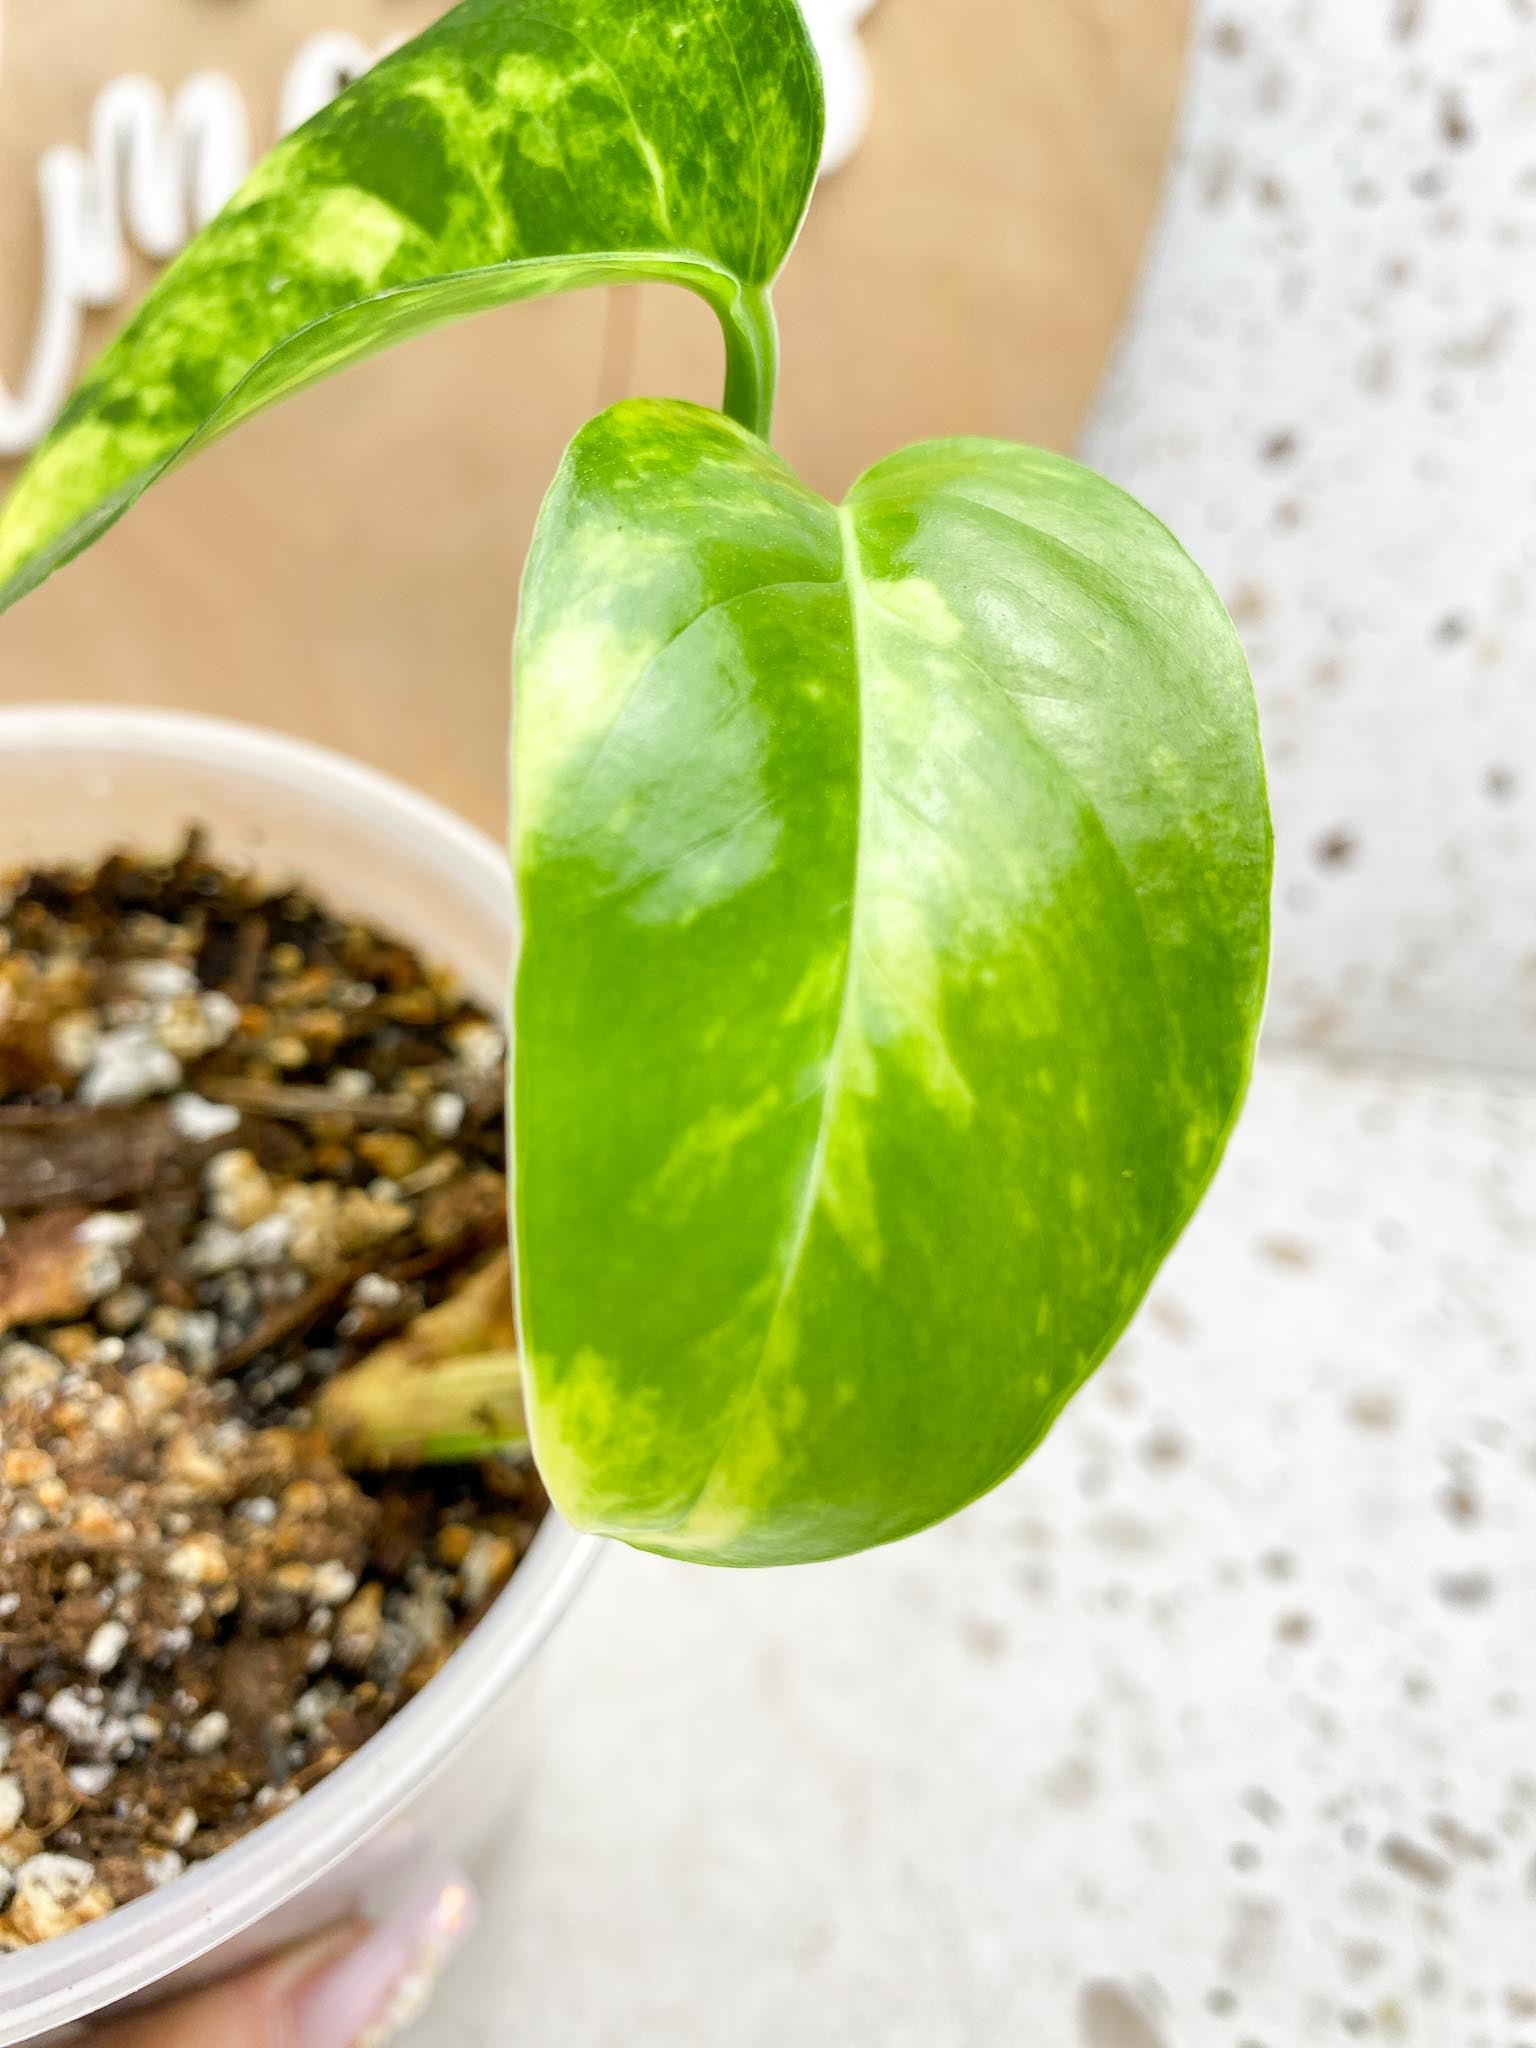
<box><xmin>516</xmin><ymin>403</ymin><xmax>1270</xmax><ymax>1565</ymax></box>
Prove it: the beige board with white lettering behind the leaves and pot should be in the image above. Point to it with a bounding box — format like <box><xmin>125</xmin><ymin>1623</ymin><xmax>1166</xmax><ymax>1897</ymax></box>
<box><xmin>0</xmin><ymin>0</ymin><xmax>1188</xmax><ymax>827</ymax></box>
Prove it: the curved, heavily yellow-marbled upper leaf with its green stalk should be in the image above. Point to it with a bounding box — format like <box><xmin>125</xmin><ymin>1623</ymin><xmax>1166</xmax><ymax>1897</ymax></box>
<box><xmin>0</xmin><ymin>0</ymin><xmax>823</xmax><ymax>610</ymax></box>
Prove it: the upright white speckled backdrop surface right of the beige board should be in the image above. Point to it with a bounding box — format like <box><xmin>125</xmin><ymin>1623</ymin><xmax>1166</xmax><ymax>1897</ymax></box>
<box><xmin>1085</xmin><ymin>0</ymin><xmax>1536</xmax><ymax>1065</ymax></box>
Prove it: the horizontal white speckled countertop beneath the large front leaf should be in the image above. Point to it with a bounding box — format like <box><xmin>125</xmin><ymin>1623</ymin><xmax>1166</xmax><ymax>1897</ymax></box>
<box><xmin>412</xmin><ymin>1057</ymin><xmax>1536</xmax><ymax>2048</ymax></box>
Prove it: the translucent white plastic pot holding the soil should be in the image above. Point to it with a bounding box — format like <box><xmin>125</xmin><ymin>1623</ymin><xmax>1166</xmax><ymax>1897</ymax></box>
<box><xmin>0</xmin><ymin>707</ymin><xmax>596</xmax><ymax>2048</ymax></box>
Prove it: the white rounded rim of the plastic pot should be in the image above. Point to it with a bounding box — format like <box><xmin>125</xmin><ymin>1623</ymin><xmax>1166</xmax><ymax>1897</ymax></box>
<box><xmin>0</xmin><ymin>705</ymin><xmax>600</xmax><ymax>2048</ymax></box>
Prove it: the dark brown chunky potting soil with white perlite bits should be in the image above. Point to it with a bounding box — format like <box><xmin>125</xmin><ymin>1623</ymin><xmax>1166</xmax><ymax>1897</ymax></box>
<box><xmin>0</xmin><ymin>838</ymin><xmax>545</xmax><ymax>1950</ymax></box>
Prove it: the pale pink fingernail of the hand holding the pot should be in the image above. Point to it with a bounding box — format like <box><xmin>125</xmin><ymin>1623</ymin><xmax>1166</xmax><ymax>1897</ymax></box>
<box><xmin>291</xmin><ymin>1864</ymin><xmax>479</xmax><ymax>2048</ymax></box>
